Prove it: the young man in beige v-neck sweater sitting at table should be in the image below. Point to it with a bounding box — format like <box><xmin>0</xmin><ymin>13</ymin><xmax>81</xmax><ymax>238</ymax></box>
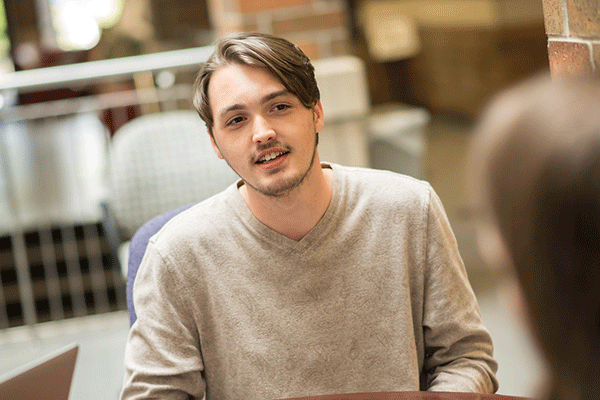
<box><xmin>122</xmin><ymin>34</ymin><xmax>497</xmax><ymax>400</ymax></box>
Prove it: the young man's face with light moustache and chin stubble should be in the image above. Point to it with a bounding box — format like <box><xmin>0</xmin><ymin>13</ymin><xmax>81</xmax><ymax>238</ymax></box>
<box><xmin>208</xmin><ymin>64</ymin><xmax>323</xmax><ymax>196</ymax></box>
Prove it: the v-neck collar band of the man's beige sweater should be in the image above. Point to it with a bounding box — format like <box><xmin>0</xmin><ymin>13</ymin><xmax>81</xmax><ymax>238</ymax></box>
<box><xmin>230</xmin><ymin>163</ymin><xmax>341</xmax><ymax>253</ymax></box>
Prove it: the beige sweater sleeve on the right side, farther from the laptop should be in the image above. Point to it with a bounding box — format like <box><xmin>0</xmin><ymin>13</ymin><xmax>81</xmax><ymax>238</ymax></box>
<box><xmin>423</xmin><ymin>190</ymin><xmax>498</xmax><ymax>393</ymax></box>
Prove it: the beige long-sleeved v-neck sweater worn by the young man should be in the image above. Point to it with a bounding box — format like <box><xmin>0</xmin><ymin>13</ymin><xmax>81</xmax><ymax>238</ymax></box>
<box><xmin>122</xmin><ymin>165</ymin><xmax>497</xmax><ymax>400</ymax></box>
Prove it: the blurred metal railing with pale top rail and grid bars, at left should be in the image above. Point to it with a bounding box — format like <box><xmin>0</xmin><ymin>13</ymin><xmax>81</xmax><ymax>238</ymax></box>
<box><xmin>0</xmin><ymin>47</ymin><xmax>212</xmax><ymax>329</ymax></box>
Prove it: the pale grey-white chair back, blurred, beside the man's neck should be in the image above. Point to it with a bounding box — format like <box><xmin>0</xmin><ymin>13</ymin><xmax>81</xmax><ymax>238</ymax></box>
<box><xmin>105</xmin><ymin>110</ymin><xmax>237</xmax><ymax>275</ymax></box>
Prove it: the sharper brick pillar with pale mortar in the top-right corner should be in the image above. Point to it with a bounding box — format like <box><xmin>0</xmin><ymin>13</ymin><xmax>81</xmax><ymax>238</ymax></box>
<box><xmin>543</xmin><ymin>0</ymin><xmax>600</xmax><ymax>78</ymax></box>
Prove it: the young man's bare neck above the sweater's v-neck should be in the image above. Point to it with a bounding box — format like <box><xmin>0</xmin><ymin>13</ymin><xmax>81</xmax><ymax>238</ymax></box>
<box><xmin>240</xmin><ymin>160</ymin><xmax>333</xmax><ymax>241</ymax></box>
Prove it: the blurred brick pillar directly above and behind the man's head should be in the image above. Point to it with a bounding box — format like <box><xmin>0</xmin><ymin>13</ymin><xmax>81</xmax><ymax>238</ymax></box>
<box><xmin>209</xmin><ymin>0</ymin><xmax>350</xmax><ymax>59</ymax></box>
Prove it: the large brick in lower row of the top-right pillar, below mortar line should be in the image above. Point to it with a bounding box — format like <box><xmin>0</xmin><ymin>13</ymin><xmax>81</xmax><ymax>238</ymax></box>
<box><xmin>548</xmin><ymin>40</ymin><xmax>594</xmax><ymax>78</ymax></box>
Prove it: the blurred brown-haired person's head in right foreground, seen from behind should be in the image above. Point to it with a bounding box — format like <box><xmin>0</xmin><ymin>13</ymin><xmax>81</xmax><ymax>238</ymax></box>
<box><xmin>471</xmin><ymin>77</ymin><xmax>600</xmax><ymax>399</ymax></box>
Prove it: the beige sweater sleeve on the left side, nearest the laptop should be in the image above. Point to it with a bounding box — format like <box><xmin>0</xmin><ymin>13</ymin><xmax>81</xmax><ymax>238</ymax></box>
<box><xmin>121</xmin><ymin>241</ymin><xmax>205</xmax><ymax>400</ymax></box>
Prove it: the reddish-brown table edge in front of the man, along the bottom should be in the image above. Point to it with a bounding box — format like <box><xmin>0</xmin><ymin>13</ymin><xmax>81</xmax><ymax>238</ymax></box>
<box><xmin>281</xmin><ymin>392</ymin><xmax>527</xmax><ymax>400</ymax></box>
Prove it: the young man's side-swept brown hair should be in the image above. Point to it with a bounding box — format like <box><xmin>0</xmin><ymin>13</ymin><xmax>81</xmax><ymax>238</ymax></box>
<box><xmin>193</xmin><ymin>33</ymin><xmax>320</xmax><ymax>131</ymax></box>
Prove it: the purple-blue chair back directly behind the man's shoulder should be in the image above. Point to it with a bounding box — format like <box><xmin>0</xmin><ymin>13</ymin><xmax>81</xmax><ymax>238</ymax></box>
<box><xmin>127</xmin><ymin>204</ymin><xmax>192</xmax><ymax>326</ymax></box>
